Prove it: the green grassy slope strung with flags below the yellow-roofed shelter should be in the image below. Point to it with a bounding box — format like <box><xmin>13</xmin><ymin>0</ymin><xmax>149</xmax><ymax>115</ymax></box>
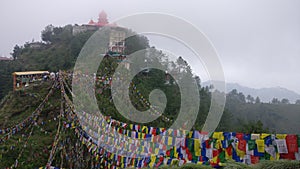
<box><xmin>0</xmin><ymin>82</ymin><xmax>97</xmax><ymax>169</ymax></box>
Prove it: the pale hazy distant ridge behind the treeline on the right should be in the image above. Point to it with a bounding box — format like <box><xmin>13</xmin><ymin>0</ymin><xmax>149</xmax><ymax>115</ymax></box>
<box><xmin>202</xmin><ymin>81</ymin><xmax>300</xmax><ymax>103</ymax></box>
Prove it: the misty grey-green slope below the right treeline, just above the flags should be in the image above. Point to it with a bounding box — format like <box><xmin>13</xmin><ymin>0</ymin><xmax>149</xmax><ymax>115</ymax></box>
<box><xmin>226</xmin><ymin>103</ymin><xmax>300</xmax><ymax>134</ymax></box>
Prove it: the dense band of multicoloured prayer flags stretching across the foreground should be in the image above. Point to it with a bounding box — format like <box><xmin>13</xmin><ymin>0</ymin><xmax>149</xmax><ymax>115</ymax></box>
<box><xmin>58</xmin><ymin>75</ymin><xmax>300</xmax><ymax>168</ymax></box>
